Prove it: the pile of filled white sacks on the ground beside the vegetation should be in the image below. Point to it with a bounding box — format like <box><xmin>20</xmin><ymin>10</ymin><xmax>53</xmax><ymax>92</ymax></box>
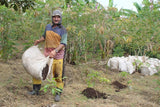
<box><xmin>108</xmin><ymin>56</ymin><xmax>160</xmax><ymax>75</ymax></box>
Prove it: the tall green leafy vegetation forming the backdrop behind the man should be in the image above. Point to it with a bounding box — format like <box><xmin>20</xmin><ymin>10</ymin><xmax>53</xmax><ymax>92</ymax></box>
<box><xmin>0</xmin><ymin>0</ymin><xmax>160</xmax><ymax>63</ymax></box>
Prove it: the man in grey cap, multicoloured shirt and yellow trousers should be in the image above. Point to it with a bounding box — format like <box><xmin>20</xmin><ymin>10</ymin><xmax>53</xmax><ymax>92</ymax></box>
<box><xmin>30</xmin><ymin>10</ymin><xmax>67</xmax><ymax>101</ymax></box>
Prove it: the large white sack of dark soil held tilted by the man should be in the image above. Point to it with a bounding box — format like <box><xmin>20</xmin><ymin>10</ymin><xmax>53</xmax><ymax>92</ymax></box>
<box><xmin>22</xmin><ymin>46</ymin><xmax>53</xmax><ymax>80</ymax></box>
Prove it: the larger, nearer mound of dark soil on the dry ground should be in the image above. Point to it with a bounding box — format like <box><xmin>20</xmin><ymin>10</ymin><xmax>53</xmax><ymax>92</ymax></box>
<box><xmin>82</xmin><ymin>88</ymin><xmax>107</xmax><ymax>99</ymax></box>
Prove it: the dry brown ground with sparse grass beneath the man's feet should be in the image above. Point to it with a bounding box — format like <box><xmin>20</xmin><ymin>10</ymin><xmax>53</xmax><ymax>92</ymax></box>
<box><xmin>0</xmin><ymin>59</ymin><xmax>160</xmax><ymax>107</ymax></box>
